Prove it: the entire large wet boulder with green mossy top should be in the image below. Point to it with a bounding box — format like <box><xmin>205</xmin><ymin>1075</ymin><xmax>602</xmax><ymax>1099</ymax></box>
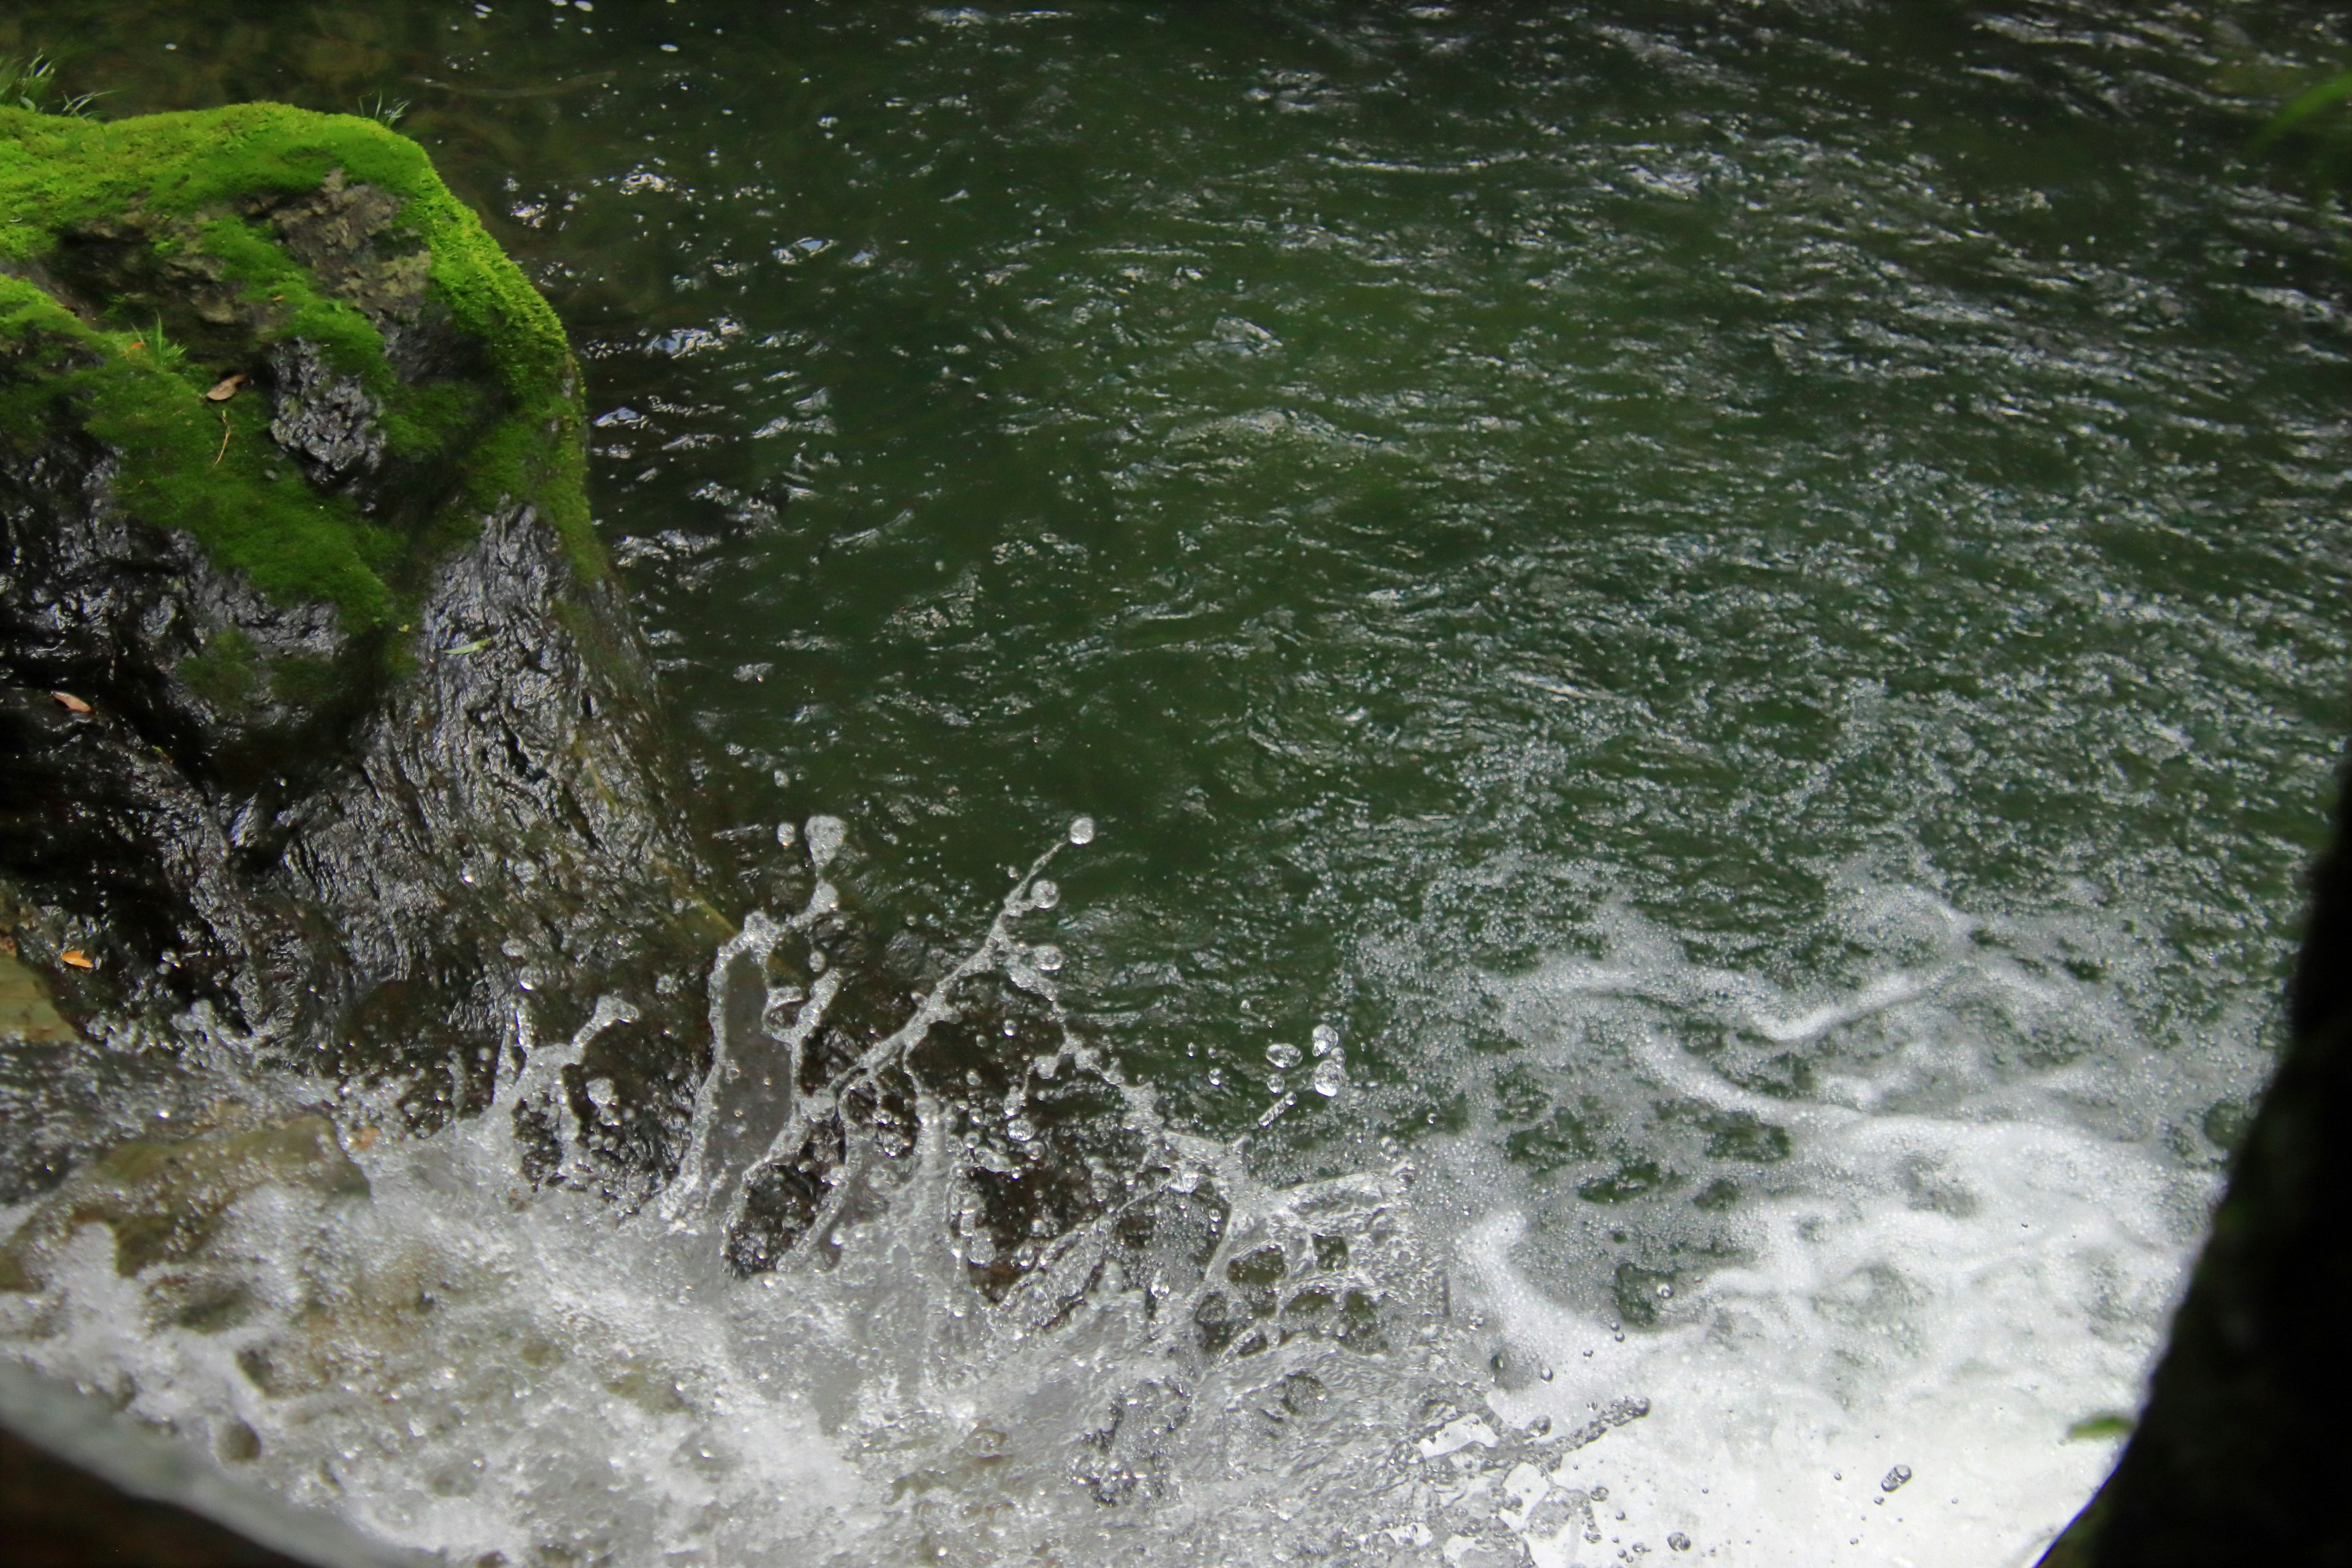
<box><xmin>0</xmin><ymin>104</ymin><xmax>722</xmax><ymax>1194</ymax></box>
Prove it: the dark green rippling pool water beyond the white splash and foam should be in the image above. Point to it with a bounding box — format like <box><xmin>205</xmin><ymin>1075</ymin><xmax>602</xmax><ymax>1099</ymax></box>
<box><xmin>0</xmin><ymin>0</ymin><xmax>2352</xmax><ymax>1561</ymax></box>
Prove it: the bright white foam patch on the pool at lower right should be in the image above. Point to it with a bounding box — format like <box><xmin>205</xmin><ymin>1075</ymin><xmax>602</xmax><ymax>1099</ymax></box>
<box><xmin>1411</xmin><ymin>895</ymin><xmax>2213</xmax><ymax>1568</ymax></box>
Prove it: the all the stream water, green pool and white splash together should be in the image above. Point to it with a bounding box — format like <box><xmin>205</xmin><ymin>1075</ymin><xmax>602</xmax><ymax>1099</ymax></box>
<box><xmin>0</xmin><ymin>0</ymin><xmax>2352</xmax><ymax>1568</ymax></box>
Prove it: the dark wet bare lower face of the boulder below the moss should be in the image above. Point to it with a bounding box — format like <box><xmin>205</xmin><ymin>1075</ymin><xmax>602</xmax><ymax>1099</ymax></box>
<box><xmin>0</xmin><ymin>425</ymin><xmax>720</xmax><ymax>1152</ymax></box>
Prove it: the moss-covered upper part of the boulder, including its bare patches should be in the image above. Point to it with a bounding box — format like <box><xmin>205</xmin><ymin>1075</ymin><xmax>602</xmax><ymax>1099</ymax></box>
<box><xmin>0</xmin><ymin>104</ymin><xmax>602</xmax><ymax>637</ymax></box>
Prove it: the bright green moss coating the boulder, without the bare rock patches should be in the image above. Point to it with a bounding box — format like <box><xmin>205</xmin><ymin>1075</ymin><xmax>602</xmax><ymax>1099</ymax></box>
<box><xmin>0</xmin><ymin>104</ymin><xmax>605</xmax><ymax>630</ymax></box>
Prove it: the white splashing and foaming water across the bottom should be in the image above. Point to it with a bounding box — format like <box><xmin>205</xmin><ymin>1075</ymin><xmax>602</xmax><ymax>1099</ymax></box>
<box><xmin>0</xmin><ymin>830</ymin><xmax>2211</xmax><ymax>1568</ymax></box>
